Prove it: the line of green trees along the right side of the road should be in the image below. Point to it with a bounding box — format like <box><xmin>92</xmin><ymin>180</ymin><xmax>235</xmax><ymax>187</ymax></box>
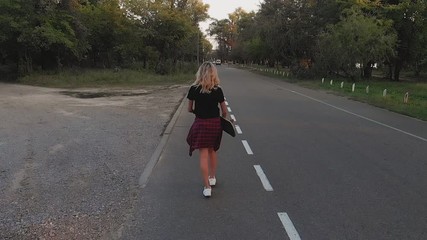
<box><xmin>209</xmin><ymin>0</ymin><xmax>427</xmax><ymax>81</ymax></box>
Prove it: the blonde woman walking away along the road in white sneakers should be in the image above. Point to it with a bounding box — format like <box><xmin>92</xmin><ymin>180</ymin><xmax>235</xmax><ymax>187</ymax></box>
<box><xmin>187</xmin><ymin>62</ymin><xmax>227</xmax><ymax>197</ymax></box>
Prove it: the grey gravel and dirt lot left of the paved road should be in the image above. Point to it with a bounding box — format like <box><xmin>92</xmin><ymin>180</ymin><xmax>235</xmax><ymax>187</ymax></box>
<box><xmin>0</xmin><ymin>84</ymin><xmax>187</xmax><ymax>239</ymax></box>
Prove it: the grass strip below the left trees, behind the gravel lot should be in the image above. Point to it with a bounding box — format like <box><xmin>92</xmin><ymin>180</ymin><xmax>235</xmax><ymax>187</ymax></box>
<box><xmin>18</xmin><ymin>69</ymin><xmax>195</xmax><ymax>88</ymax></box>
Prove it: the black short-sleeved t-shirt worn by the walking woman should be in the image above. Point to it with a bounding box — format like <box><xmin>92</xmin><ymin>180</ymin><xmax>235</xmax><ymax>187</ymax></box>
<box><xmin>187</xmin><ymin>86</ymin><xmax>224</xmax><ymax>118</ymax></box>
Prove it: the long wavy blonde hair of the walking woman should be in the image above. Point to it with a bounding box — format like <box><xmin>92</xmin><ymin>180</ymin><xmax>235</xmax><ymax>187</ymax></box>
<box><xmin>193</xmin><ymin>62</ymin><xmax>219</xmax><ymax>93</ymax></box>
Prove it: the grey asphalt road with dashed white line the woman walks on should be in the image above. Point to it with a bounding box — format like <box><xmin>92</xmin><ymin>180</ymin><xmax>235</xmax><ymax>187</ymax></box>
<box><xmin>121</xmin><ymin>66</ymin><xmax>427</xmax><ymax>240</ymax></box>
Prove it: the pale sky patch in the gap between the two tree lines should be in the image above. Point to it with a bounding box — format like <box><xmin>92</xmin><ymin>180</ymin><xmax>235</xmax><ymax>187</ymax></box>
<box><xmin>200</xmin><ymin>0</ymin><xmax>262</xmax><ymax>35</ymax></box>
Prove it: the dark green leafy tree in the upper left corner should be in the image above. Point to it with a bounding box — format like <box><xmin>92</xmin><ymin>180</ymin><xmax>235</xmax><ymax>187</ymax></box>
<box><xmin>0</xmin><ymin>0</ymin><xmax>84</xmax><ymax>73</ymax></box>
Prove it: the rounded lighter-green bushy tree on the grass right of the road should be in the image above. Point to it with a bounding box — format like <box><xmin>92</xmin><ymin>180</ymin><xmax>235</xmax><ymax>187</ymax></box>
<box><xmin>316</xmin><ymin>7</ymin><xmax>397</xmax><ymax>79</ymax></box>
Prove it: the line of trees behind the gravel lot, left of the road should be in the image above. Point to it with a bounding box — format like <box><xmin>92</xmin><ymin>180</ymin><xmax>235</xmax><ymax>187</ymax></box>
<box><xmin>0</xmin><ymin>0</ymin><xmax>212</xmax><ymax>78</ymax></box>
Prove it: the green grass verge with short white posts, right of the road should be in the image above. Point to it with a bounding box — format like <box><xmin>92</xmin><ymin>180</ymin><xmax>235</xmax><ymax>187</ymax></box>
<box><xmin>241</xmin><ymin>63</ymin><xmax>427</xmax><ymax>121</ymax></box>
